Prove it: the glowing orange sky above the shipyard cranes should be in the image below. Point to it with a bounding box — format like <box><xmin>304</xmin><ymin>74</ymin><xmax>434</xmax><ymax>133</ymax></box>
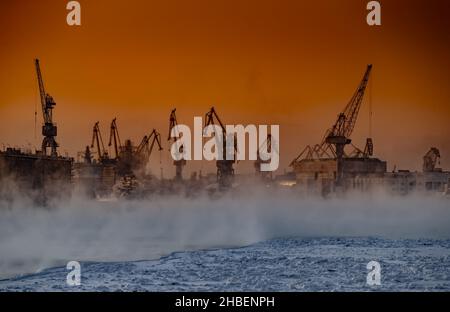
<box><xmin>0</xmin><ymin>0</ymin><xmax>450</xmax><ymax>175</ymax></box>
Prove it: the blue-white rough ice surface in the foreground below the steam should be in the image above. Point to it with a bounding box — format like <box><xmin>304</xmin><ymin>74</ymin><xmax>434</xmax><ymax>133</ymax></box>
<box><xmin>0</xmin><ymin>238</ymin><xmax>450</xmax><ymax>291</ymax></box>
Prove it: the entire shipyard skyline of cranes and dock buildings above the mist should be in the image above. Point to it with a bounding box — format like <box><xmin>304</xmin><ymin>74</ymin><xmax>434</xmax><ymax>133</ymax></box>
<box><xmin>0</xmin><ymin>59</ymin><xmax>450</xmax><ymax>202</ymax></box>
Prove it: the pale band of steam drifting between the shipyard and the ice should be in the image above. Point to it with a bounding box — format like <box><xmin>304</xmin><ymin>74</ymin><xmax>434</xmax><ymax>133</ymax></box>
<box><xmin>0</xmin><ymin>186</ymin><xmax>450</xmax><ymax>277</ymax></box>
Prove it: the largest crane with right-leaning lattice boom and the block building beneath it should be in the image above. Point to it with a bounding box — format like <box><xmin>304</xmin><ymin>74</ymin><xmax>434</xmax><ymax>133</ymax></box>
<box><xmin>291</xmin><ymin>65</ymin><xmax>387</xmax><ymax>195</ymax></box>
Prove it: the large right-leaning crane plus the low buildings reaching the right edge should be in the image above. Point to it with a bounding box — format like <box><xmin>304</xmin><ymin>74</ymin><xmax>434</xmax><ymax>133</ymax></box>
<box><xmin>291</xmin><ymin>65</ymin><xmax>450</xmax><ymax>196</ymax></box>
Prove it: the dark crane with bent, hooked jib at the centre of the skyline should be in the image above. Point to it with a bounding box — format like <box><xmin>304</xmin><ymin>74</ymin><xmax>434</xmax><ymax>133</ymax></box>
<box><xmin>205</xmin><ymin>107</ymin><xmax>237</xmax><ymax>187</ymax></box>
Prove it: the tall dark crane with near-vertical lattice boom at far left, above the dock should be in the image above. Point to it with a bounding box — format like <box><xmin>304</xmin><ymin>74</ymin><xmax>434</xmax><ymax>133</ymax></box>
<box><xmin>35</xmin><ymin>59</ymin><xmax>58</xmax><ymax>157</ymax></box>
